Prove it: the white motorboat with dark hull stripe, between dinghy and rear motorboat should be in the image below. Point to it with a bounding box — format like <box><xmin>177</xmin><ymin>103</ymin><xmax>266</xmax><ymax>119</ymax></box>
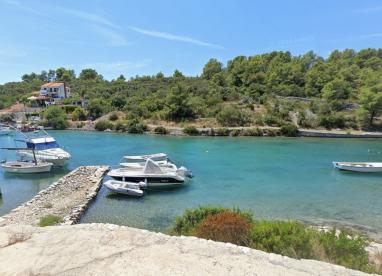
<box><xmin>107</xmin><ymin>158</ymin><xmax>185</xmax><ymax>188</ymax></box>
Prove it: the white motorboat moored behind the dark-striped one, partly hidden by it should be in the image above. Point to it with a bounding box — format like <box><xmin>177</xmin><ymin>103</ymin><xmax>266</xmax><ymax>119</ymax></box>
<box><xmin>119</xmin><ymin>153</ymin><xmax>192</xmax><ymax>178</ymax></box>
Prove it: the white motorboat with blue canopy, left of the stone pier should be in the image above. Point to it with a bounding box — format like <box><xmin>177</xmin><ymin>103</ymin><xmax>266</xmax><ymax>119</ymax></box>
<box><xmin>16</xmin><ymin>130</ymin><xmax>71</xmax><ymax>166</ymax></box>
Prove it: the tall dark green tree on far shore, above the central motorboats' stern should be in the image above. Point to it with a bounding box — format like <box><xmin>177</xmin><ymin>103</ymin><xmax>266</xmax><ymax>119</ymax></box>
<box><xmin>167</xmin><ymin>84</ymin><xmax>195</xmax><ymax>121</ymax></box>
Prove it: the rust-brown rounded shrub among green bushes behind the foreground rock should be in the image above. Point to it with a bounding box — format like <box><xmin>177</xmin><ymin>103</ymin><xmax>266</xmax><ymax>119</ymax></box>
<box><xmin>196</xmin><ymin>211</ymin><xmax>251</xmax><ymax>245</ymax></box>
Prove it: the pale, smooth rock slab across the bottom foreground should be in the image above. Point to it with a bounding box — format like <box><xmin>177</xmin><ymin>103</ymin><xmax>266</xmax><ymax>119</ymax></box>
<box><xmin>0</xmin><ymin>224</ymin><xmax>374</xmax><ymax>276</ymax></box>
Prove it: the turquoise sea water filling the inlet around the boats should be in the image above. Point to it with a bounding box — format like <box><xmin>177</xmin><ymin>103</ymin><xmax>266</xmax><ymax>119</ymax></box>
<box><xmin>0</xmin><ymin>131</ymin><xmax>382</xmax><ymax>233</ymax></box>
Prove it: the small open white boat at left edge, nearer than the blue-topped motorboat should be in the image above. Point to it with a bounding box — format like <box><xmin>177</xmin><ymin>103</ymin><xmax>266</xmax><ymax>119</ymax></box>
<box><xmin>0</xmin><ymin>161</ymin><xmax>53</xmax><ymax>173</ymax></box>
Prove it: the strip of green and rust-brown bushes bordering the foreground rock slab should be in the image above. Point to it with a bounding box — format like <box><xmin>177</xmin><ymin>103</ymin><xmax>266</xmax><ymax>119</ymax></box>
<box><xmin>171</xmin><ymin>207</ymin><xmax>375</xmax><ymax>272</ymax></box>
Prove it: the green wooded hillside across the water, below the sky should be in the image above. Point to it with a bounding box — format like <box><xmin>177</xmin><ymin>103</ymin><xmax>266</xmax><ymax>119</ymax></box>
<box><xmin>0</xmin><ymin>49</ymin><xmax>382</xmax><ymax>132</ymax></box>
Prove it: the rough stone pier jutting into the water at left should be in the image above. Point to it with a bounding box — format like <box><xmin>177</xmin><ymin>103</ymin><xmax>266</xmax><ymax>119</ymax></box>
<box><xmin>0</xmin><ymin>166</ymin><xmax>109</xmax><ymax>226</ymax></box>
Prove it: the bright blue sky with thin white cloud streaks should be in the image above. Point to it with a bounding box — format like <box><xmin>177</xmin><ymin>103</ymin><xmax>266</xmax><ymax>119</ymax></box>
<box><xmin>0</xmin><ymin>0</ymin><xmax>382</xmax><ymax>83</ymax></box>
